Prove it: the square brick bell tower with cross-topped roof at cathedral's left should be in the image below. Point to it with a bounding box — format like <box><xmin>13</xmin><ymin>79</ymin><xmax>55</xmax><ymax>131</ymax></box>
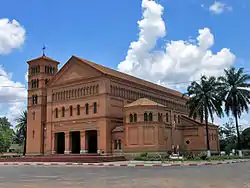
<box><xmin>26</xmin><ymin>53</ymin><xmax>59</xmax><ymax>155</ymax></box>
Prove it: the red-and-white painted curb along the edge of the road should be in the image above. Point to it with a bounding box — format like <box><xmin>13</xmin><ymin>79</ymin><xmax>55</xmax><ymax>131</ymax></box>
<box><xmin>0</xmin><ymin>160</ymin><xmax>250</xmax><ymax>167</ymax></box>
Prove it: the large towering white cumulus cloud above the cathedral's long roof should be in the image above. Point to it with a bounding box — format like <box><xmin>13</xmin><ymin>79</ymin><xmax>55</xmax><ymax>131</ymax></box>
<box><xmin>118</xmin><ymin>0</ymin><xmax>236</xmax><ymax>88</ymax></box>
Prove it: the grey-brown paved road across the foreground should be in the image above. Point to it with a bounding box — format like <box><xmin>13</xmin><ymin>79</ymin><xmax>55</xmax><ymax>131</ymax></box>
<box><xmin>0</xmin><ymin>163</ymin><xmax>250</xmax><ymax>188</ymax></box>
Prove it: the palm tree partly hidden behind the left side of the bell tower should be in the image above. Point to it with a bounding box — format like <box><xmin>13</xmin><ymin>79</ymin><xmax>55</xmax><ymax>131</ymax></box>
<box><xmin>16</xmin><ymin>110</ymin><xmax>27</xmax><ymax>155</ymax></box>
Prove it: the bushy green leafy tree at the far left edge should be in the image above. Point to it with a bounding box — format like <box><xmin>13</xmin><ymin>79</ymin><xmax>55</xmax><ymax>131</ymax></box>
<box><xmin>0</xmin><ymin>117</ymin><xmax>13</xmax><ymax>153</ymax></box>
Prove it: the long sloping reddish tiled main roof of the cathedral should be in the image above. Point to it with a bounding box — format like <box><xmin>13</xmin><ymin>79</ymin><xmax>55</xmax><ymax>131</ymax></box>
<box><xmin>73</xmin><ymin>56</ymin><xmax>187</xmax><ymax>99</ymax></box>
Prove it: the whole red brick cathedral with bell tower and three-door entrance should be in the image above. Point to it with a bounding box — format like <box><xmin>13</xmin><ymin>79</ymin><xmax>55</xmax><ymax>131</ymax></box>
<box><xmin>27</xmin><ymin>55</ymin><xmax>219</xmax><ymax>155</ymax></box>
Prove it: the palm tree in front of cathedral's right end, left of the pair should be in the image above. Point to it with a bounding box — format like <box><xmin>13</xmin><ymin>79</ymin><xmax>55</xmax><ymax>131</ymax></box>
<box><xmin>184</xmin><ymin>76</ymin><xmax>223</xmax><ymax>157</ymax></box>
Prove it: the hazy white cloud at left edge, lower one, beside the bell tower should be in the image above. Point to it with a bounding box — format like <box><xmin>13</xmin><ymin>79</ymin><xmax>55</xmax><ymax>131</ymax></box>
<box><xmin>0</xmin><ymin>66</ymin><xmax>27</xmax><ymax>123</ymax></box>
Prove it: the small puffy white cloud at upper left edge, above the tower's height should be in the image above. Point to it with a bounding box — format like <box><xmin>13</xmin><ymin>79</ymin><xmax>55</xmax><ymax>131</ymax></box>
<box><xmin>0</xmin><ymin>19</ymin><xmax>25</xmax><ymax>55</ymax></box>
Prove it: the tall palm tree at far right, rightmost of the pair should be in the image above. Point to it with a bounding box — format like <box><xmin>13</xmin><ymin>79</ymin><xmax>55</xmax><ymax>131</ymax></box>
<box><xmin>219</xmin><ymin>67</ymin><xmax>250</xmax><ymax>155</ymax></box>
